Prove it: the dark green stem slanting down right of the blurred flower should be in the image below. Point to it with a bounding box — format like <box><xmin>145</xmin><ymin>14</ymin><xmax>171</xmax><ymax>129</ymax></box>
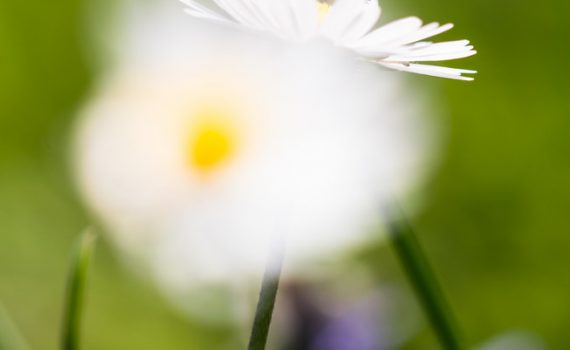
<box><xmin>387</xmin><ymin>208</ymin><xmax>463</xmax><ymax>350</ymax></box>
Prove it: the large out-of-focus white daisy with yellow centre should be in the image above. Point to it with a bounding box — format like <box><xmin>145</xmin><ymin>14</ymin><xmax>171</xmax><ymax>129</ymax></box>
<box><xmin>74</xmin><ymin>2</ymin><xmax>427</xmax><ymax>320</ymax></box>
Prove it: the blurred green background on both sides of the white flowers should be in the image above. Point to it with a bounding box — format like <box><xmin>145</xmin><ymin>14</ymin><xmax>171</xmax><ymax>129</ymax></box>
<box><xmin>0</xmin><ymin>0</ymin><xmax>570</xmax><ymax>350</ymax></box>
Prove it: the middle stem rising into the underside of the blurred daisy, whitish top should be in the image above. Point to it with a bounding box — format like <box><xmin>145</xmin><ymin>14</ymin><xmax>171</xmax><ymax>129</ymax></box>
<box><xmin>247</xmin><ymin>231</ymin><xmax>285</xmax><ymax>350</ymax></box>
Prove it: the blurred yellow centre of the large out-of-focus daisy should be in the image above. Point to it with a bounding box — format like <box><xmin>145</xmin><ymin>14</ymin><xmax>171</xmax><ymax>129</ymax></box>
<box><xmin>186</xmin><ymin>111</ymin><xmax>237</xmax><ymax>173</ymax></box>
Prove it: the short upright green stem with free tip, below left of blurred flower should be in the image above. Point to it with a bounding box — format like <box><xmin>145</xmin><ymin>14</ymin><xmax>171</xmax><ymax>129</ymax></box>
<box><xmin>61</xmin><ymin>230</ymin><xmax>96</xmax><ymax>350</ymax></box>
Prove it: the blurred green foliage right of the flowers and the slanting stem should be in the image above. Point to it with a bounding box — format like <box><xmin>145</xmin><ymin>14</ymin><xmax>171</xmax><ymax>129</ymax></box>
<box><xmin>392</xmin><ymin>0</ymin><xmax>570</xmax><ymax>349</ymax></box>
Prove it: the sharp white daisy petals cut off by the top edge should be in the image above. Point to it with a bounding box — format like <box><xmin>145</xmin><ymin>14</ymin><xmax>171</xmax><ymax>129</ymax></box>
<box><xmin>182</xmin><ymin>0</ymin><xmax>476</xmax><ymax>80</ymax></box>
